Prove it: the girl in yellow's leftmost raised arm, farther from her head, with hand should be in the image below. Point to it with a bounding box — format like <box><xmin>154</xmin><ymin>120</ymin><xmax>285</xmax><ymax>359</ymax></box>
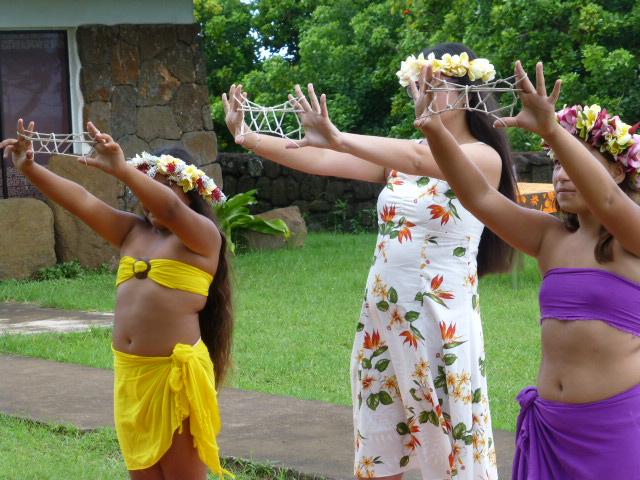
<box><xmin>0</xmin><ymin>119</ymin><xmax>141</xmax><ymax>247</ymax></box>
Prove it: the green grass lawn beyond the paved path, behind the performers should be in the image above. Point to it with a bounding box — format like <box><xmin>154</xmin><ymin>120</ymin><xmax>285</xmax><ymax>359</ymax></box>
<box><xmin>0</xmin><ymin>234</ymin><xmax>540</xmax><ymax>430</ymax></box>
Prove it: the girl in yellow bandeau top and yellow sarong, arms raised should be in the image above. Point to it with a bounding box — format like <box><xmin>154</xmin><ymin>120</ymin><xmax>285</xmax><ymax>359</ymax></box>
<box><xmin>0</xmin><ymin>120</ymin><xmax>232</xmax><ymax>480</ymax></box>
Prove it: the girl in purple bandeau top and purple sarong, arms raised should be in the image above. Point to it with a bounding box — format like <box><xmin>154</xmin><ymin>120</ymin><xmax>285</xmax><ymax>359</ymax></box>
<box><xmin>416</xmin><ymin>62</ymin><xmax>640</xmax><ymax>480</ymax></box>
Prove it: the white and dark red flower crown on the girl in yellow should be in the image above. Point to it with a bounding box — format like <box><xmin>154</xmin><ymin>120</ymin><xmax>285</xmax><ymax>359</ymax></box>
<box><xmin>127</xmin><ymin>152</ymin><xmax>226</xmax><ymax>205</ymax></box>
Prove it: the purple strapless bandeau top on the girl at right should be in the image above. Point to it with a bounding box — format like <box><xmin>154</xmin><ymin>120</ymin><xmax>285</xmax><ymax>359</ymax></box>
<box><xmin>540</xmin><ymin>268</ymin><xmax>640</xmax><ymax>336</ymax></box>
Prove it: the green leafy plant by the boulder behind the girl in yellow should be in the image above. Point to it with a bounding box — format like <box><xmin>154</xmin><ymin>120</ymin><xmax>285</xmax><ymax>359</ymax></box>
<box><xmin>215</xmin><ymin>189</ymin><xmax>291</xmax><ymax>253</ymax></box>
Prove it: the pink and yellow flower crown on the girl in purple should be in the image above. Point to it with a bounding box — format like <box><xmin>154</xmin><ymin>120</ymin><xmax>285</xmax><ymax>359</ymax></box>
<box><xmin>546</xmin><ymin>104</ymin><xmax>640</xmax><ymax>189</ymax></box>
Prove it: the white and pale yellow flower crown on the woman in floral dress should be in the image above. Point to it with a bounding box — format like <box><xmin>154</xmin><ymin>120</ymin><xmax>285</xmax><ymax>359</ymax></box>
<box><xmin>396</xmin><ymin>52</ymin><xmax>496</xmax><ymax>87</ymax></box>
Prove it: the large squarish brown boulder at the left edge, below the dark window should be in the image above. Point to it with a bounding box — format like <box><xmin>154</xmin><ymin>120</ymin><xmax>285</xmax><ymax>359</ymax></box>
<box><xmin>0</xmin><ymin>198</ymin><xmax>56</xmax><ymax>280</ymax></box>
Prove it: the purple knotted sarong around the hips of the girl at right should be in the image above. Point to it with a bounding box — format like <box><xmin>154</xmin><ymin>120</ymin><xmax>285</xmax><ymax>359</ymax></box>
<box><xmin>512</xmin><ymin>385</ymin><xmax>640</xmax><ymax>480</ymax></box>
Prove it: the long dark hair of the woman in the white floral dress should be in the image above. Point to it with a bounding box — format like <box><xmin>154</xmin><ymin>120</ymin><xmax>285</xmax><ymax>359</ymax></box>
<box><xmin>422</xmin><ymin>43</ymin><xmax>518</xmax><ymax>276</ymax></box>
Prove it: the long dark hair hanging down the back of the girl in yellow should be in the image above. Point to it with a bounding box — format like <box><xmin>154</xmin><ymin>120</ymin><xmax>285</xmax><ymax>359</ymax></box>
<box><xmin>153</xmin><ymin>146</ymin><xmax>233</xmax><ymax>385</ymax></box>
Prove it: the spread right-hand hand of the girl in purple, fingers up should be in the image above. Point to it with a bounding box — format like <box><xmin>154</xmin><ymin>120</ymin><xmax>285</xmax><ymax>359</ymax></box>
<box><xmin>494</xmin><ymin>60</ymin><xmax>562</xmax><ymax>137</ymax></box>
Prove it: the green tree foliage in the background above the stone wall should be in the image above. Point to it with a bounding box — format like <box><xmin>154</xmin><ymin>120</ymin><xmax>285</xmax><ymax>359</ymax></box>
<box><xmin>201</xmin><ymin>0</ymin><xmax>640</xmax><ymax>150</ymax></box>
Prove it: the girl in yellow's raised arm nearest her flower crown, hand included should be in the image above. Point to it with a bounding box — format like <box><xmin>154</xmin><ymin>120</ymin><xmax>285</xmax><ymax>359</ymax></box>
<box><xmin>86</xmin><ymin>123</ymin><xmax>222</xmax><ymax>257</ymax></box>
